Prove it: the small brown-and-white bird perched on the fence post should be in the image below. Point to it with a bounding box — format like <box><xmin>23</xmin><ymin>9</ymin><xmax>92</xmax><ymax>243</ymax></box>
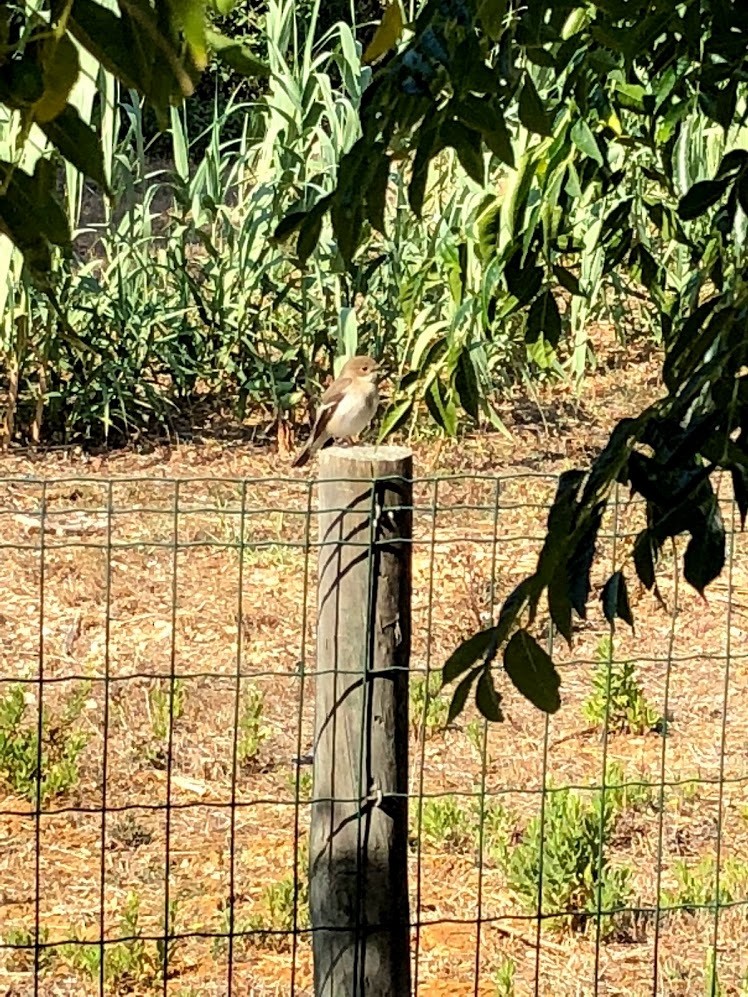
<box><xmin>292</xmin><ymin>356</ymin><xmax>380</xmax><ymax>467</ymax></box>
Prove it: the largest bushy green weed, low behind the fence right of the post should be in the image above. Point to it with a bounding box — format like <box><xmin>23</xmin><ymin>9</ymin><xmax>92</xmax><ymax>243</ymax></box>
<box><xmin>505</xmin><ymin>789</ymin><xmax>631</xmax><ymax>937</ymax></box>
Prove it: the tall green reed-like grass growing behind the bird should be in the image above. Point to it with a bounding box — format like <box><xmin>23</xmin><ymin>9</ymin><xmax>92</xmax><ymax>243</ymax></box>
<box><xmin>0</xmin><ymin>0</ymin><xmax>744</xmax><ymax>442</ymax></box>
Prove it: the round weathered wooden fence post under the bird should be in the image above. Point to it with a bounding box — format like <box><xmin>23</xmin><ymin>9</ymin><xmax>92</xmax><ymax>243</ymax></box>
<box><xmin>309</xmin><ymin>447</ymin><xmax>413</xmax><ymax>997</ymax></box>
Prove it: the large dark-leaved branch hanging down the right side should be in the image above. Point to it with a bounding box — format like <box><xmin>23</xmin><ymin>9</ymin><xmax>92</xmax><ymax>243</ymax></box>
<box><xmin>276</xmin><ymin>0</ymin><xmax>748</xmax><ymax>720</ymax></box>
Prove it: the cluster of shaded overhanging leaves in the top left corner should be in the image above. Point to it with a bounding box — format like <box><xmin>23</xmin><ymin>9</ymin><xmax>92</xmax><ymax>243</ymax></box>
<box><xmin>0</xmin><ymin>0</ymin><xmax>266</xmax><ymax>275</ymax></box>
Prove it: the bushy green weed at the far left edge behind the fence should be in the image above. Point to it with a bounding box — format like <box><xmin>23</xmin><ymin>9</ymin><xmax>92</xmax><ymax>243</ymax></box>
<box><xmin>0</xmin><ymin>682</ymin><xmax>91</xmax><ymax>804</ymax></box>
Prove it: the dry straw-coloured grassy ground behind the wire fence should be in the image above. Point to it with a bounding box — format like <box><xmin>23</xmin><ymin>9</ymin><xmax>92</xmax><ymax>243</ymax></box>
<box><xmin>0</xmin><ymin>336</ymin><xmax>748</xmax><ymax>997</ymax></box>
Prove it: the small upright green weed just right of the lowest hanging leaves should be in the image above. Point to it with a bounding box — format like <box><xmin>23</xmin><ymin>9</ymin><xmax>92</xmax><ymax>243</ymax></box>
<box><xmin>583</xmin><ymin>637</ymin><xmax>663</xmax><ymax>734</ymax></box>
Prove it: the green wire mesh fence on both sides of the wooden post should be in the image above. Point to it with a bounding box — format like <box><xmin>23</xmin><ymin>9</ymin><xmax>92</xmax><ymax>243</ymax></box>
<box><xmin>0</xmin><ymin>473</ymin><xmax>748</xmax><ymax>997</ymax></box>
